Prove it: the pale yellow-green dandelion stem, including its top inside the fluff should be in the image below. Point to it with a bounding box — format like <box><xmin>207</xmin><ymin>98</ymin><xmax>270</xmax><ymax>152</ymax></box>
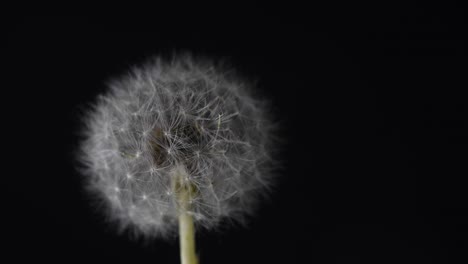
<box><xmin>173</xmin><ymin>167</ymin><xmax>198</xmax><ymax>264</ymax></box>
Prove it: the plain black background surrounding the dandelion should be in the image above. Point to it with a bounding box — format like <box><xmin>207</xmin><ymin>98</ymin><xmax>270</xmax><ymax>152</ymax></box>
<box><xmin>5</xmin><ymin>5</ymin><xmax>468</xmax><ymax>264</ymax></box>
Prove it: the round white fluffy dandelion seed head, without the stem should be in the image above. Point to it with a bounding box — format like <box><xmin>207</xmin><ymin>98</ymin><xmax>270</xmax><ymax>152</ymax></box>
<box><xmin>80</xmin><ymin>55</ymin><xmax>274</xmax><ymax>236</ymax></box>
